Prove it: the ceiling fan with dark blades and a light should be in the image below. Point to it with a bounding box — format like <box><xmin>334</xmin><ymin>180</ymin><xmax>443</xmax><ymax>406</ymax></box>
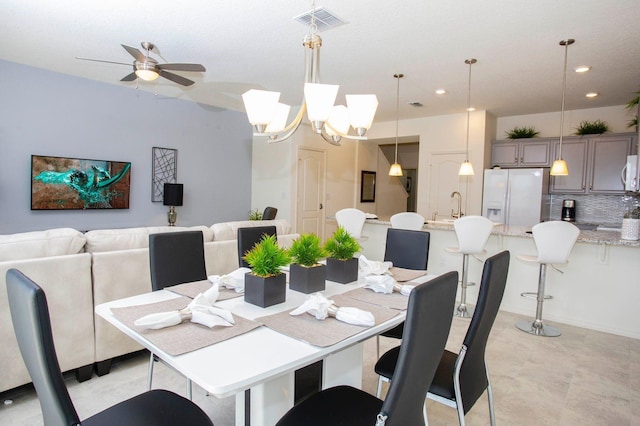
<box><xmin>76</xmin><ymin>41</ymin><xmax>206</xmax><ymax>86</ymax></box>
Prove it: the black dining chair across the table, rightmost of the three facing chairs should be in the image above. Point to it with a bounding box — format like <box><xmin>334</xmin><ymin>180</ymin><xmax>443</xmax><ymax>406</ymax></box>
<box><xmin>376</xmin><ymin>228</ymin><xmax>431</xmax><ymax>358</ymax></box>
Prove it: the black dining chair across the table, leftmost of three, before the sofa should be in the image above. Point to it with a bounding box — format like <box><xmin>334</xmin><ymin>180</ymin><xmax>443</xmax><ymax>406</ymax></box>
<box><xmin>148</xmin><ymin>231</ymin><xmax>207</xmax><ymax>399</ymax></box>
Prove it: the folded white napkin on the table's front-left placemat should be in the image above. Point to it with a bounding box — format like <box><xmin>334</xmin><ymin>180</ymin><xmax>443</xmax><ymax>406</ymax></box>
<box><xmin>134</xmin><ymin>284</ymin><xmax>235</xmax><ymax>330</ymax></box>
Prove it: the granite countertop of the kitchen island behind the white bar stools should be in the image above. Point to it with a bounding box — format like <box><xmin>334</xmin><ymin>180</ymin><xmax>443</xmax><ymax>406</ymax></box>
<box><xmin>366</xmin><ymin>218</ymin><xmax>640</xmax><ymax>247</ymax></box>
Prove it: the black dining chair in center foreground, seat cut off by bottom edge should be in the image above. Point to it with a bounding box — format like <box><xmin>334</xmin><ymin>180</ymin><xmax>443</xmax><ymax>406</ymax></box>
<box><xmin>276</xmin><ymin>271</ymin><xmax>458</xmax><ymax>426</ymax></box>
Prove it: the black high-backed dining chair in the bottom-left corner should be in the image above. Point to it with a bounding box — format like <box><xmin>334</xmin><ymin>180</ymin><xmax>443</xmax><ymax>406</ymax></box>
<box><xmin>6</xmin><ymin>269</ymin><xmax>213</xmax><ymax>426</ymax></box>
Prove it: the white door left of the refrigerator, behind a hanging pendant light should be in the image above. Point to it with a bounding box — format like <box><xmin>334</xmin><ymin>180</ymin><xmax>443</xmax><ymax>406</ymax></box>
<box><xmin>426</xmin><ymin>152</ymin><xmax>468</xmax><ymax>219</ymax></box>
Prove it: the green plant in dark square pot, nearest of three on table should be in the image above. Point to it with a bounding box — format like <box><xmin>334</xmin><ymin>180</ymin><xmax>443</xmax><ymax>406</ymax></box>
<box><xmin>243</xmin><ymin>235</ymin><xmax>291</xmax><ymax>308</ymax></box>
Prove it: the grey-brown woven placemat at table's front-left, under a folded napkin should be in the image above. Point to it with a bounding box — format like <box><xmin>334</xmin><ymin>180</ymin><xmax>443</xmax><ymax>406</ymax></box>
<box><xmin>111</xmin><ymin>297</ymin><xmax>261</xmax><ymax>355</ymax></box>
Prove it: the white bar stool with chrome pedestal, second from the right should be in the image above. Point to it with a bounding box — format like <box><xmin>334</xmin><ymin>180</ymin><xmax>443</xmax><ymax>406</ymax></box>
<box><xmin>446</xmin><ymin>216</ymin><xmax>493</xmax><ymax>318</ymax></box>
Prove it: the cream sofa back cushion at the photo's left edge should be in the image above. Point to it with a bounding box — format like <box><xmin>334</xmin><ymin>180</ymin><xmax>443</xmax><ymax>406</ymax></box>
<box><xmin>0</xmin><ymin>228</ymin><xmax>86</xmax><ymax>261</ymax></box>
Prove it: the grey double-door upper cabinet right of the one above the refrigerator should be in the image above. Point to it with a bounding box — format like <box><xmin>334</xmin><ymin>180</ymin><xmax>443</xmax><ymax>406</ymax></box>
<box><xmin>549</xmin><ymin>134</ymin><xmax>635</xmax><ymax>194</ymax></box>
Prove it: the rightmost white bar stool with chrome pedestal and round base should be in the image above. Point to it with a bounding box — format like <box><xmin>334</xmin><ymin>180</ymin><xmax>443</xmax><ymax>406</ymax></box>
<box><xmin>516</xmin><ymin>220</ymin><xmax>580</xmax><ymax>337</ymax></box>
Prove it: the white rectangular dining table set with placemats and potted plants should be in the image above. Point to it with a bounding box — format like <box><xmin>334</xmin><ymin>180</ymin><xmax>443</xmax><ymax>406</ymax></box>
<box><xmin>95</xmin><ymin>275</ymin><xmax>435</xmax><ymax>426</ymax></box>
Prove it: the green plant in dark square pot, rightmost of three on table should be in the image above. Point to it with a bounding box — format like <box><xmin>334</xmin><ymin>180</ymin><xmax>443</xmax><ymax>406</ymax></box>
<box><xmin>324</xmin><ymin>226</ymin><xmax>361</xmax><ymax>284</ymax></box>
